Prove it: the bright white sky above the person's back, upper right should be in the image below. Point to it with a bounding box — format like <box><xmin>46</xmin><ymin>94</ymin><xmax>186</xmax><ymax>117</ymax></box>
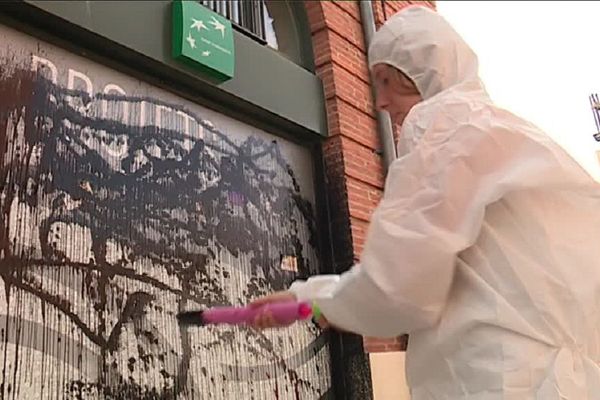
<box><xmin>437</xmin><ymin>0</ymin><xmax>600</xmax><ymax>181</ymax></box>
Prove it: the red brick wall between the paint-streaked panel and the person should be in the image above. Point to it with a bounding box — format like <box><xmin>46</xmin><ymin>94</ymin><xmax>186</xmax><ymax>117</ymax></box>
<box><xmin>305</xmin><ymin>0</ymin><xmax>435</xmax><ymax>352</ymax></box>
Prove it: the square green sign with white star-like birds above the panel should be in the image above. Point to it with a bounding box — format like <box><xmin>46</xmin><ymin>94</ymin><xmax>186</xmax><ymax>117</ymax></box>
<box><xmin>173</xmin><ymin>0</ymin><xmax>235</xmax><ymax>82</ymax></box>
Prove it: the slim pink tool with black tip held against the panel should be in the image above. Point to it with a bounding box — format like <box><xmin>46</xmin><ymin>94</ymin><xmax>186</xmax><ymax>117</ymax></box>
<box><xmin>177</xmin><ymin>301</ymin><xmax>320</xmax><ymax>326</ymax></box>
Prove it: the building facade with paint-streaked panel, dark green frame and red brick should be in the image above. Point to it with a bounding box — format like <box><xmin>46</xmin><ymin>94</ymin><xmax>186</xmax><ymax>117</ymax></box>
<box><xmin>0</xmin><ymin>1</ymin><xmax>434</xmax><ymax>399</ymax></box>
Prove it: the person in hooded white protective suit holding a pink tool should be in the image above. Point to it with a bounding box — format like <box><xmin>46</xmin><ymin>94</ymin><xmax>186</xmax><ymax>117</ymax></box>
<box><xmin>253</xmin><ymin>7</ymin><xmax>600</xmax><ymax>400</ymax></box>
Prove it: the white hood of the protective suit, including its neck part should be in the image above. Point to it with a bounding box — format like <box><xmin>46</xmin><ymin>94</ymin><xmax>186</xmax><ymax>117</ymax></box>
<box><xmin>369</xmin><ymin>6</ymin><xmax>491</xmax><ymax>156</ymax></box>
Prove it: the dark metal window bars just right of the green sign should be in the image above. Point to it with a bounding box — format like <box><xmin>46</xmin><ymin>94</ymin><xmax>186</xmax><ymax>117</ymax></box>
<box><xmin>200</xmin><ymin>0</ymin><xmax>267</xmax><ymax>44</ymax></box>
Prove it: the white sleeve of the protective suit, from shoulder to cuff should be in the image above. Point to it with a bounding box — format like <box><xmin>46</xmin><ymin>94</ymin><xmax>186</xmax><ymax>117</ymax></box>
<box><xmin>291</xmin><ymin>112</ymin><xmax>555</xmax><ymax>337</ymax></box>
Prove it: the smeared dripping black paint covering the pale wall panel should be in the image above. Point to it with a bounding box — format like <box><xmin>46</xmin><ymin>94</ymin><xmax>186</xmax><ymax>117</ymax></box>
<box><xmin>0</xmin><ymin>60</ymin><xmax>330</xmax><ymax>399</ymax></box>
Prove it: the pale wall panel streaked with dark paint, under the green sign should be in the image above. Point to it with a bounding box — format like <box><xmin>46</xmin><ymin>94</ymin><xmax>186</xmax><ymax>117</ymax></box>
<box><xmin>0</xmin><ymin>26</ymin><xmax>331</xmax><ymax>400</ymax></box>
